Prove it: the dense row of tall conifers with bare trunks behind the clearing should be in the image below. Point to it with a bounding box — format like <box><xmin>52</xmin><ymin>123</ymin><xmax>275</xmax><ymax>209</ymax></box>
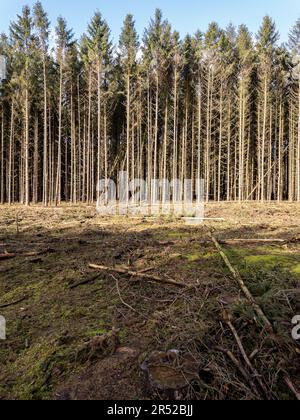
<box><xmin>0</xmin><ymin>1</ymin><xmax>300</xmax><ymax>205</ymax></box>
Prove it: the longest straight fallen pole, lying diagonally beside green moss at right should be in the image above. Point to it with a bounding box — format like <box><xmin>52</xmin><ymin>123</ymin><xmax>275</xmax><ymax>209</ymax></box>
<box><xmin>209</xmin><ymin>232</ymin><xmax>273</xmax><ymax>333</ymax></box>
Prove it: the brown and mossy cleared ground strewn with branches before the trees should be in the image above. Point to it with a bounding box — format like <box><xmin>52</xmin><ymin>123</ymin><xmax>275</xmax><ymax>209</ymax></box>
<box><xmin>0</xmin><ymin>203</ymin><xmax>300</xmax><ymax>400</ymax></box>
